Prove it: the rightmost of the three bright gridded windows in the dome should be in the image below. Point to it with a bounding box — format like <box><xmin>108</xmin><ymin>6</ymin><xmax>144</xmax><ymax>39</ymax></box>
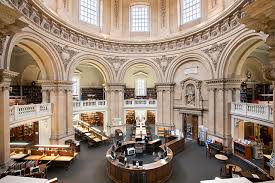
<box><xmin>181</xmin><ymin>0</ymin><xmax>201</xmax><ymax>24</ymax></box>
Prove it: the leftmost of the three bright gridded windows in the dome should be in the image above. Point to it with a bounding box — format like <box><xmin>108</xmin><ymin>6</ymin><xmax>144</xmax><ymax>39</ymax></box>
<box><xmin>80</xmin><ymin>0</ymin><xmax>100</xmax><ymax>25</ymax></box>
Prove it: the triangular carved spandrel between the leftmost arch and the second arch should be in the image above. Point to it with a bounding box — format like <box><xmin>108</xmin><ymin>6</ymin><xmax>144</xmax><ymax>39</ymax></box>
<box><xmin>52</xmin><ymin>43</ymin><xmax>79</xmax><ymax>69</ymax></box>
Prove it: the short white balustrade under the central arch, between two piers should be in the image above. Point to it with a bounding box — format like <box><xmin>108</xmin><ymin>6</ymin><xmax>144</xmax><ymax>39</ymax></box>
<box><xmin>124</xmin><ymin>99</ymin><xmax>157</xmax><ymax>108</ymax></box>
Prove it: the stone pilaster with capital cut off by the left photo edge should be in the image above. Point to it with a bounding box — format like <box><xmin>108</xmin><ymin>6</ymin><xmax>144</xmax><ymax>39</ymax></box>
<box><xmin>0</xmin><ymin>69</ymin><xmax>18</xmax><ymax>169</ymax></box>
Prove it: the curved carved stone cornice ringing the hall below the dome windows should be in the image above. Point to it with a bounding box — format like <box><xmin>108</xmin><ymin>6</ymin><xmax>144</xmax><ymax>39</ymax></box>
<box><xmin>5</xmin><ymin>0</ymin><xmax>250</xmax><ymax>54</ymax></box>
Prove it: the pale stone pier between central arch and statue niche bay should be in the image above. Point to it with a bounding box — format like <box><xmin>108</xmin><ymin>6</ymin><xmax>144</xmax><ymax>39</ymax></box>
<box><xmin>156</xmin><ymin>83</ymin><xmax>175</xmax><ymax>130</ymax></box>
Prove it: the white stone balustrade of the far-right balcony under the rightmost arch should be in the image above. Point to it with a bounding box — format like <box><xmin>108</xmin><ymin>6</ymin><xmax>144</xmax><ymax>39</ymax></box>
<box><xmin>231</xmin><ymin>103</ymin><xmax>273</xmax><ymax>123</ymax></box>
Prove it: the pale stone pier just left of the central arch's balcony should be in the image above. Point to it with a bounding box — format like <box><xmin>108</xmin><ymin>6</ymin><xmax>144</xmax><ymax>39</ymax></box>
<box><xmin>105</xmin><ymin>83</ymin><xmax>126</xmax><ymax>134</ymax></box>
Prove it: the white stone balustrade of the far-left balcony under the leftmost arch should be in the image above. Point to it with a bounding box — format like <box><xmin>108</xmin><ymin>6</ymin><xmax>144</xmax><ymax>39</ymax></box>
<box><xmin>10</xmin><ymin>103</ymin><xmax>52</xmax><ymax>125</ymax></box>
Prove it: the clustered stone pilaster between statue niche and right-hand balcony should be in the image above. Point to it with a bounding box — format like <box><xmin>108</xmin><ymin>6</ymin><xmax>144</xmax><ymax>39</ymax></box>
<box><xmin>206</xmin><ymin>78</ymin><xmax>242</xmax><ymax>147</ymax></box>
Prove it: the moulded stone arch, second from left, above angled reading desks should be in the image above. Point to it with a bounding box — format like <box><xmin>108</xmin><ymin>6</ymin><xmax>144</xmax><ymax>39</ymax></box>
<box><xmin>67</xmin><ymin>54</ymin><xmax>114</xmax><ymax>83</ymax></box>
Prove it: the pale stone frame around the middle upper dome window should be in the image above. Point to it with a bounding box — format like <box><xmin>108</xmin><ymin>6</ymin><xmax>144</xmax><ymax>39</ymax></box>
<box><xmin>129</xmin><ymin>3</ymin><xmax>151</xmax><ymax>33</ymax></box>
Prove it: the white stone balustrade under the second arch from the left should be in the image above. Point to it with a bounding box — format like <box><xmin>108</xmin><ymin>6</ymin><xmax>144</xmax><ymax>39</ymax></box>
<box><xmin>73</xmin><ymin>100</ymin><xmax>107</xmax><ymax>114</ymax></box>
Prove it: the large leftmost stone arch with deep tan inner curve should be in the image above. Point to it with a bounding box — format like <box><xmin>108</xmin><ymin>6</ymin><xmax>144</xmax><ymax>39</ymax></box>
<box><xmin>3</xmin><ymin>32</ymin><xmax>64</xmax><ymax>80</ymax></box>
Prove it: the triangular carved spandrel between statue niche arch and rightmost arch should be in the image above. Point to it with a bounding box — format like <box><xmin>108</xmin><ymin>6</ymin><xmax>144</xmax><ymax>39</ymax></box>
<box><xmin>203</xmin><ymin>41</ymin><xmax>228</xmax><ymax>70</ymax></box>
